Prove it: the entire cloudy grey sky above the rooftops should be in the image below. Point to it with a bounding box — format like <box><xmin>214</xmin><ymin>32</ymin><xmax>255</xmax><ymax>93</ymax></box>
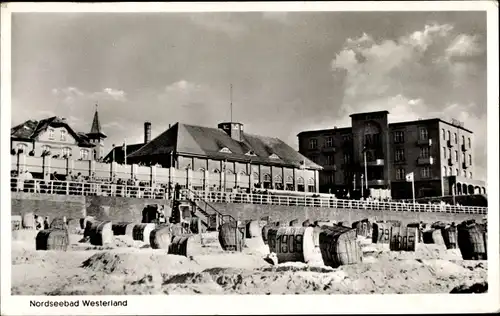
<box><xmin>12</xmin><ymin>12</ymin><xmax>487</xmax><ymax>179</ymax></box>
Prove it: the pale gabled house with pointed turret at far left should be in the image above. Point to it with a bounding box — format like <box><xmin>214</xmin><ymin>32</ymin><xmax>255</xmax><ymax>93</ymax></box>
<box><xmin>10</xmin><ymin>110</ymin><xmax>106</xmax><ymax>160</ymax></box>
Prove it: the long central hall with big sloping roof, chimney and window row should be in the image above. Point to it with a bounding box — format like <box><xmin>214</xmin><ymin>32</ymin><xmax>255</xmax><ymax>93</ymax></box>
<box><xmin>123</xmin><ymin>122</ymin><xmax>322</xmax><ymax>192</ymax></box>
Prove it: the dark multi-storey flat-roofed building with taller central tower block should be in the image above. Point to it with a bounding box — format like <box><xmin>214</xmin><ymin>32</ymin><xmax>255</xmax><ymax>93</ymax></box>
<box><xmin>298</xmin><ymin>111</ymin><xmax>486</xmax><ymax>199</ymax></box>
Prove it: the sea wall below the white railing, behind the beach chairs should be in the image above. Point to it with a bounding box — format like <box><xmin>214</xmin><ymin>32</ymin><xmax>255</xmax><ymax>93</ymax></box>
<box><xmin>12</xmin><ymin>193</ymin><xmax>484</xmax><ymax>225</ymax></box>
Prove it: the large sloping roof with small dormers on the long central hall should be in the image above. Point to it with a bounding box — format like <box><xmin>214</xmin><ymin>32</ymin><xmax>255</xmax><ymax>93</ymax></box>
<box><xmin>127</xmin><ymin>123</ymin><xmax>322</xmax><ymax>170</ymax></box>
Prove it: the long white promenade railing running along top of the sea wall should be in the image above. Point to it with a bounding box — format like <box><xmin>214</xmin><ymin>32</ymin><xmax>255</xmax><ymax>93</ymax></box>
<box><xmin>11</xmin><ymin>178</ymin><xmax>488</xmax><ymax>214</ymax></box>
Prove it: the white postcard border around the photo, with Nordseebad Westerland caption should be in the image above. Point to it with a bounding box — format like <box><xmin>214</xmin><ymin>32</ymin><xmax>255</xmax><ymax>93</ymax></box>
<box><xmin>0</xmin><ymin>1</ymin><xmax>500</xmax><ymax>315</ymax></box>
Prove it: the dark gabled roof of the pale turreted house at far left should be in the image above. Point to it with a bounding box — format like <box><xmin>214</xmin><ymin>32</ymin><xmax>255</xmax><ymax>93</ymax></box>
<box><xmin>10</xmin><ymin>116</ymin><xmax>94</xmax><ymax>147</ymax></box>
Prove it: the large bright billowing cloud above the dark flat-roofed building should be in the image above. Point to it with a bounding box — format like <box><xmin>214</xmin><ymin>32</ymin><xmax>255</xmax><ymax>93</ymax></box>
<box><xmin>332</xmin><ymin>24</ymin><xmax>486</xmax><ymax>177</ymax></box>
